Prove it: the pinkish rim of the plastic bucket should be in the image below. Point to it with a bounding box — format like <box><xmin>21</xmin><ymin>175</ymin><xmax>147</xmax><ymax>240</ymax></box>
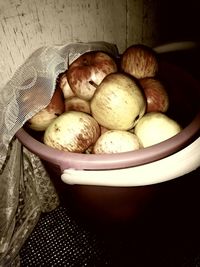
<box><xmin>15</xmin><ymin>62</ymin><xmax>200</xmax><ymax>171</ymax></box>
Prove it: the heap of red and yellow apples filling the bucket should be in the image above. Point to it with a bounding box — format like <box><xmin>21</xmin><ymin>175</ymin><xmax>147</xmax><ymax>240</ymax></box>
<box><xmin>27</xmin><ymin>45</ymin><xmax>189</xmax><ymax>154</ymax></box>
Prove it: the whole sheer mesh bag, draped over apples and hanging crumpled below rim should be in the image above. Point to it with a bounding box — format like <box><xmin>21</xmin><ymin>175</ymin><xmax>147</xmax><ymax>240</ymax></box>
<box><xmin>0</xmin><ymin>42</ymin><xmax>118</xmax><ymax>266</ymax></box>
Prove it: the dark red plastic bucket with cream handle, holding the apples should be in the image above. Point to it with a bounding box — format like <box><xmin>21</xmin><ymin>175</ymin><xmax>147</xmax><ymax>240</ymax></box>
<box><xmin>16</xmin><ymin>53</ymin><xmax>200</xmax><ymax>225</ymax></box>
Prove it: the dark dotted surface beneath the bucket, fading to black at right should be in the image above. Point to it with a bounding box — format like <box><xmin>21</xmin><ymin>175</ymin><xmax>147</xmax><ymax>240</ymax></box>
<box><xmin>20</xmin><ymin>169</ymin><xmax>200</xmax><ymax>267</ymax></box>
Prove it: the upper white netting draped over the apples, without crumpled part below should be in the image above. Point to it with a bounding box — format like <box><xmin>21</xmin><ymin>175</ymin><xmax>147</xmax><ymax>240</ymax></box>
<box><xmin>0</xmin><ymin>42</ymin><xmax>118</xmax><ymax>168</ymax></box>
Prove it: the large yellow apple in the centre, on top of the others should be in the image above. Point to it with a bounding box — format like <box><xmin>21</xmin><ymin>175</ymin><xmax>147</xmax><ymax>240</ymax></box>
<box><xmin>91</xmin><ymin>73</ymin><xmax>146</xmax><ymax>130</ymax></box>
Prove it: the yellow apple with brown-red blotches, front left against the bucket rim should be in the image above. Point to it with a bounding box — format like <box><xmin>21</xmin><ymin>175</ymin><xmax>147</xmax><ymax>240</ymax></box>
<box><xmin>44</xmin><ymin>111</ymin><xmax>100</xmax><ymax>153</ymax></box>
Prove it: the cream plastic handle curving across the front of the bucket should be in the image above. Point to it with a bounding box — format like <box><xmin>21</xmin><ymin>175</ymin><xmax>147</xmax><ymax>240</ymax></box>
<box><xmin>61</xmin><ymin>137</ymin><xmax>200</xmax><ymax>186</ymax></box>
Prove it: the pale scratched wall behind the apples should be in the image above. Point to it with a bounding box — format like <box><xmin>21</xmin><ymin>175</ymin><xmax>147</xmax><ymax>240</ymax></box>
<box><xmin>0</xmin><ymin>0</ymin><xmax>161</xmax><ymax>87</ymax></box>
